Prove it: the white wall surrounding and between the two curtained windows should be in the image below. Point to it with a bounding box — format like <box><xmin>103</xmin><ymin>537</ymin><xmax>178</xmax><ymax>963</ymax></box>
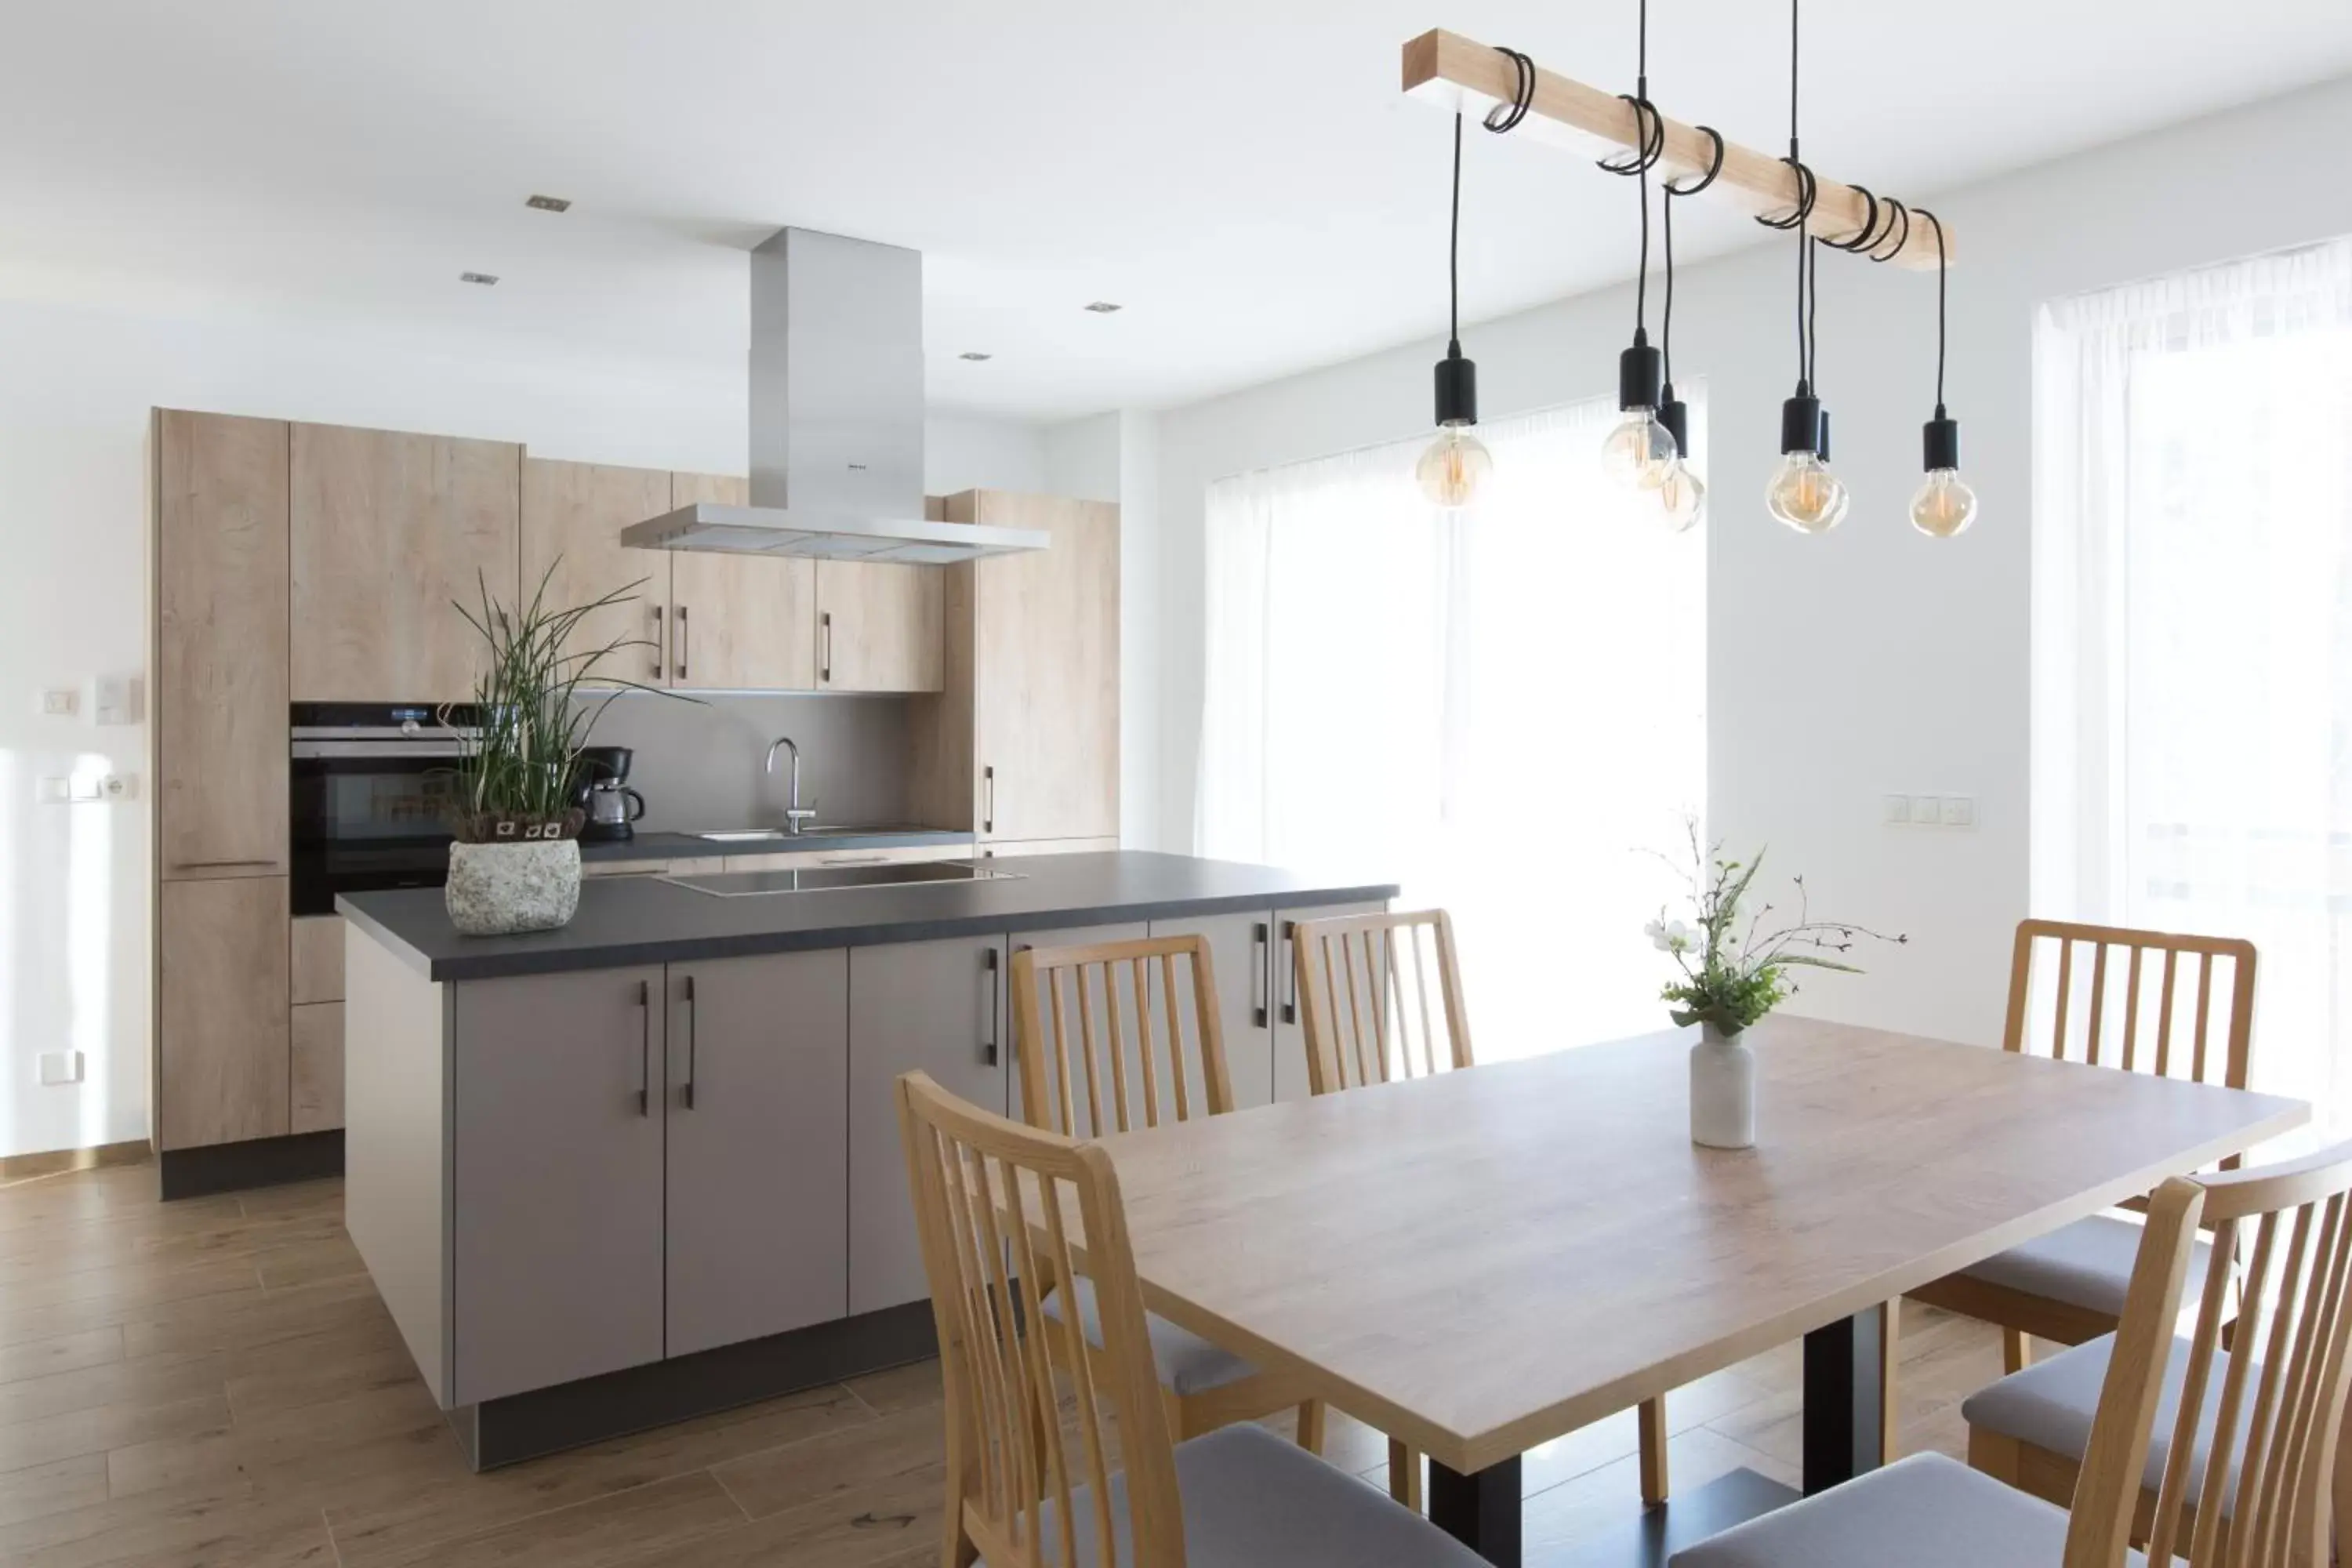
<box><xmin>1157</xmin><ymin>82</ymin><xmax>2352</xmax><ymax>1041</ymax></box>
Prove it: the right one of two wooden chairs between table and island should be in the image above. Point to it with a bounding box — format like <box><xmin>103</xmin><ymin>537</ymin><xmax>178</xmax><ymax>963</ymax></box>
<box><xmin>1291</xmin><ymin>909</ymin><xmax>1665</xmax><ymax>1509</ymax></box>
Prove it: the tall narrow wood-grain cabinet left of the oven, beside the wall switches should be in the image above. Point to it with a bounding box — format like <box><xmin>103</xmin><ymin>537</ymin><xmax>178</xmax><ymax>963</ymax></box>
<box><xmin>148</xmin><ymin>409</ymin><xmax>292</xmax><ymax>1149</ymax></box>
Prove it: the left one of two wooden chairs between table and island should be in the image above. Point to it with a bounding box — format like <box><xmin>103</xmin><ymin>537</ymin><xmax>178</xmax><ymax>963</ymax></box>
<box><xmin>1014</xmin><ymin>935</ymin><xmax>1324</xmax><ymax>1453</ymax></box>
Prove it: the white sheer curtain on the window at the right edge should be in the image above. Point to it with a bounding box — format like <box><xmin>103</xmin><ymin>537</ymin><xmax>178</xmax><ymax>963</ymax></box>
<box><xmin>2032</xmin><ymin>240</ymin><xmax>2352</xmax><ymax>1131</ymax></box>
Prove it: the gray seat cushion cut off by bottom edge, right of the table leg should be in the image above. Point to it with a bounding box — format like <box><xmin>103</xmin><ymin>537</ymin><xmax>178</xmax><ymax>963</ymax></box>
<box><xmin>1672</xmin><ymin>1453</ymin><xmax>2145</xmax><ymax>1568</ymax></box>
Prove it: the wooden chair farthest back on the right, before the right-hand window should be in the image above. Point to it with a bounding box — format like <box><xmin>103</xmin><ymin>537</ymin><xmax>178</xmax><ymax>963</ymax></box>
<box><xmin>1879</xmin><ymin>919</ymin><xmax>2256</xmax><ymax>1457</ymax></box>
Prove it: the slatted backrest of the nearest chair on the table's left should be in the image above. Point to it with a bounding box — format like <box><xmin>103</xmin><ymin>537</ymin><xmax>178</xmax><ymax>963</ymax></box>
<box><xmin>898</xmin><ymin>1072</ymin><xmax>1185</xmax><ymax>1568</ymax></box>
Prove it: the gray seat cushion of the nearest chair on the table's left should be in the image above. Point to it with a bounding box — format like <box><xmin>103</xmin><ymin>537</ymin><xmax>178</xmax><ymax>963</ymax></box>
<box><xmin>993</xmin><ymin>1422</ymin><xmax>1486</xmax><ymax>1568</ymax></box>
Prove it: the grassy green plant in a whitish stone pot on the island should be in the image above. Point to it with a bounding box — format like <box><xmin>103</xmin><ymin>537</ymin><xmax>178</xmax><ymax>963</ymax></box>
<box><xmin>442</xmin><ymin>562</ymin><xmax>670</xmax><ymax>935</ymax></box>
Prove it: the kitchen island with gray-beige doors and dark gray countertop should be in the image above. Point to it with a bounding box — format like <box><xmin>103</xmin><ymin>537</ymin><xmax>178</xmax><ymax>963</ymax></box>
<box><xmin>336</xmin><ymin>851</ymin><xmax>1397</xmax><ymax>1467</ymax></box>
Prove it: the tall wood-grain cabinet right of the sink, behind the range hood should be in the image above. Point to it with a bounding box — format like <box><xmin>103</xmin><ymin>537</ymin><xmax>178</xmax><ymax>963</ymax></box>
<box><xmin>915</xmin><ymin>489</ymin><xmax>1120</xmax><ymax>853</ymax></box>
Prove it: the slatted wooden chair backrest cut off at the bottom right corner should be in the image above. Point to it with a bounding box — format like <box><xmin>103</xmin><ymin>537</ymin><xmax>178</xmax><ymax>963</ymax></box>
<box><xmin>2107</xmin><ymin>1145</ymin><xmax>2352</xmax><ymax>1568</ymax></box>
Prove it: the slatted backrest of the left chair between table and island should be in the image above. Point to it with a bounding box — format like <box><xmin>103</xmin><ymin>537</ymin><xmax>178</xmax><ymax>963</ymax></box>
<box><xmin>1014</xmin><ymin>935</ymin><xmax>1232</xmax><ymax>1138</ymax></box>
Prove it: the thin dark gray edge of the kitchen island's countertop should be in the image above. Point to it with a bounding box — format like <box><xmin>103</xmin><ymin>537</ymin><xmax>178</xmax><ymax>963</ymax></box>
<box><xmin>334</xmin><ymin>881</ymin><xmax>1402</xmax><ymax>982</ymax></box>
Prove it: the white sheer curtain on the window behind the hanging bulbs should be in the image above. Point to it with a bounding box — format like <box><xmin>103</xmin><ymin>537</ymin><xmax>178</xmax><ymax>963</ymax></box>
<box><xmin>1195</xmin><ymin>388</ymin><xmax>1708</xmax><ymax>1058</ymax></box>
